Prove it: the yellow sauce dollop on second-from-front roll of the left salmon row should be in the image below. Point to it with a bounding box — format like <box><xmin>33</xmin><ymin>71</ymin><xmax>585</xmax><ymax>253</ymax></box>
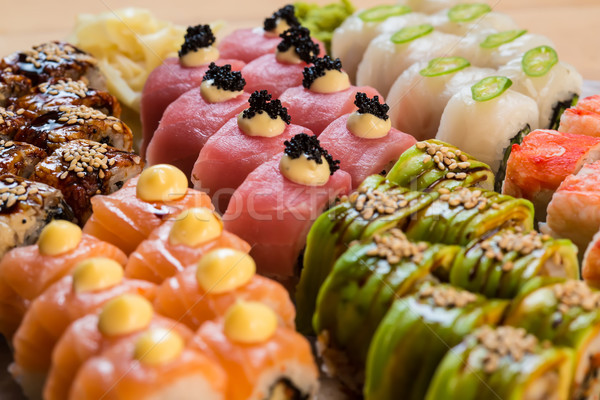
<box><xmin>98</xmin><ymin>294</ymin><xmax>154</xmax><ymax>336</ymax></box>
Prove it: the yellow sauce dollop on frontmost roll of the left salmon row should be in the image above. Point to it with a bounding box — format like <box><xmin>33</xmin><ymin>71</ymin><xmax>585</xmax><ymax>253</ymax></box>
<box><xmin>134</xmin><ymin>328</ymin><xmax>184</xmax><ymax>366</ymax></box>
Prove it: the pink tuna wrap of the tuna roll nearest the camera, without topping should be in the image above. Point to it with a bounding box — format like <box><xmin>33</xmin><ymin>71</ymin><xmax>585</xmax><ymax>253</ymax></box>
<box><xmin>223</xmin><ymin>155</ymin><xmax>351</xmax><ymax>280</ymax></box>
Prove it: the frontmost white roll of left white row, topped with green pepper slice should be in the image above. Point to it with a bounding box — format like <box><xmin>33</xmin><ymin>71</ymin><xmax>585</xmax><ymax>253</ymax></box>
<box><xmin>436</xmin><ymin>77</ymin><xmax>539</xmax><ymax>172</ymax></box>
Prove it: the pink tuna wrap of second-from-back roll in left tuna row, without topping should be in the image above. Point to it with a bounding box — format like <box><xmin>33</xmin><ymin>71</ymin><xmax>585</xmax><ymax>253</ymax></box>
<box><xmin>146</xmin><ymin>88</ymin><xmax>250</xmax><ymax>176</ymax></box>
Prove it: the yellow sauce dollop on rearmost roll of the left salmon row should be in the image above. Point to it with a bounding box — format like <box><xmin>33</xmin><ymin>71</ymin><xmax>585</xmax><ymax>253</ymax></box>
<box><xmin>38</xmin><ymin>220</ymin><xmax>82</xmax><ymax>256</ymax></box>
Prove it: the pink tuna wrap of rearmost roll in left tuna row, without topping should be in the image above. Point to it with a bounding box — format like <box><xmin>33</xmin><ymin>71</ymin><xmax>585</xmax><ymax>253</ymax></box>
<box><xmin>140</xmin><ymin>57</ymin><xmax>246</xmax><ymax>156</ymax></box>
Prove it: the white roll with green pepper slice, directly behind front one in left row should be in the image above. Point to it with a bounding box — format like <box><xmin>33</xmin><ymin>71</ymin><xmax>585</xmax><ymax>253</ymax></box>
<box><xmin>386</xmin><ymin>58</ymin><xmax>495</xmax><ymax>141</ymax></box>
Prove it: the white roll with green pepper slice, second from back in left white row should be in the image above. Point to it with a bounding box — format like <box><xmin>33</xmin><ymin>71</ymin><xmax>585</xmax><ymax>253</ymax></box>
<box><xmin>356</xmin><ymin>24</ymin><xmax>460</xmax><ymax>96</ymax></box>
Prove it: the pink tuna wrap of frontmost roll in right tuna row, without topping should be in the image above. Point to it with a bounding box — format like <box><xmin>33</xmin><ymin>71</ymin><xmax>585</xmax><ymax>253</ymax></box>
<box><xmin>319</xmin><ymin>114</ymin><xmax>417</xmax><ymax>189</ymax></box>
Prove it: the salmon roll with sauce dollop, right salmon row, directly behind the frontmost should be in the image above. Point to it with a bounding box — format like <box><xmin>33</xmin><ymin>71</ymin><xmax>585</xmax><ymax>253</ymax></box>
<box><xmin>154</xmin><ymin>247</ymin><xmax>296</xmax><ymax>330</ymax></box>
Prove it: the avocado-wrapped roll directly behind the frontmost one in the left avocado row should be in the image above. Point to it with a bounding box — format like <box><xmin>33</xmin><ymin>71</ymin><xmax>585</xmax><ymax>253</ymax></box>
<box><xmin>364</xmin><ymin>284</ymin><xmax>509</xmax><ymax>400</ymax></box>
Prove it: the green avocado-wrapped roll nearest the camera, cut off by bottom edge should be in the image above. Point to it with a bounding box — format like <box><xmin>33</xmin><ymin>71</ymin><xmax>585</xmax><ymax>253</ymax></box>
<box><xmin>425</xmin><ymin>326</ymin><xmax>573</xmax><ymax>400</ymax></box>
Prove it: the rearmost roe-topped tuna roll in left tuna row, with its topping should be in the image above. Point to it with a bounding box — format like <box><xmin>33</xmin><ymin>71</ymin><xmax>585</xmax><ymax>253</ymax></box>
<box><xmin>140</xmin><ymin>25</ymin><xmax>246</xmax><ymax>157</ymax></box>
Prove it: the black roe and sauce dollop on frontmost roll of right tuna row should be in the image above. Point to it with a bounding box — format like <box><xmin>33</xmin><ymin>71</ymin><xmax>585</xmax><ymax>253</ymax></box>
<box><xmin>346</xmin><ymin>92</ymin><xmax>392</xmax><ymax>139</ymax></box>
